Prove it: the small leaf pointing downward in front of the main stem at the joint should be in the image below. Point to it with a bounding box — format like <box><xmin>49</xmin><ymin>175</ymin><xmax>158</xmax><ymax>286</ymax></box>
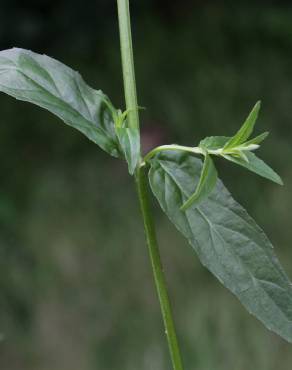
<box><xmin>116</xmin><ymin>127</ymin><xmax>140</xmax><ymax>175</ymax></box>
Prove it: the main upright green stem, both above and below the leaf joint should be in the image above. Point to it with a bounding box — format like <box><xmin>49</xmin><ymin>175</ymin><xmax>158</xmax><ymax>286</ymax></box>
<box><xmin>117</xmin><ymin>0</ymin><xmax>183</xmax><ymax>370</ymax></box>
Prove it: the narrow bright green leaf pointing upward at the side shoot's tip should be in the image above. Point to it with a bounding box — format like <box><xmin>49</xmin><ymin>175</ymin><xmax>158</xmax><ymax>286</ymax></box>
<box><xmin>224</xmin><ymin>101</ymin><xmax>261</xmax><ymax>149</ymax></box>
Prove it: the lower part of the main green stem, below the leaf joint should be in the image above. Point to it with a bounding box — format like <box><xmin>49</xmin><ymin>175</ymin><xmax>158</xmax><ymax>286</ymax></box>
<box><xmin>136</xmin><ymin>166</ymin><xmax>183</xmax><ymax>370</ymax></box>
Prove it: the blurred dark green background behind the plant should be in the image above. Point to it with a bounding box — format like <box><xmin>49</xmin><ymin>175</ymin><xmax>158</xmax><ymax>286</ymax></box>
<box><xmin>0</xmin><ymin>0</ymin><xmax>292</xmax><ymax>370</ymax></box>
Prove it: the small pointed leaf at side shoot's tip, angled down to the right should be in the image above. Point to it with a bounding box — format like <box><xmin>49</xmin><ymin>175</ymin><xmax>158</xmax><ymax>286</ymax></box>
<box><xmin>224</xmin><ymin>151</ymin><xmax>283</xmax><ymax>185</ymax></box>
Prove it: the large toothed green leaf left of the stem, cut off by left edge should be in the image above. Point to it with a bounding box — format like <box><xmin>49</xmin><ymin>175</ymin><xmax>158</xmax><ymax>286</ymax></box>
<box><xmin>0</xmin><ymin>48</ymin><xmax>120</xmax><ymax>157</ymax></box>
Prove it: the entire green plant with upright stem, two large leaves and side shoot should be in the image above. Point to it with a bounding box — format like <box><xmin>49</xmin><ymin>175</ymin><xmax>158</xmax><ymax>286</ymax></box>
<box><xmin>0</xmin><ymin>0</ymin><xmax>292</xmax><ymax>370</ymax></box>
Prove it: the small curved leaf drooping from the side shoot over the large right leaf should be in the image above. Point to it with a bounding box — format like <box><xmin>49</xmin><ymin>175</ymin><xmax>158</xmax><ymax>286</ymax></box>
<box><xmin>181</xmin><ymin>154</ymin><xmax>218</xmax><ymax>211</ymax></box>
